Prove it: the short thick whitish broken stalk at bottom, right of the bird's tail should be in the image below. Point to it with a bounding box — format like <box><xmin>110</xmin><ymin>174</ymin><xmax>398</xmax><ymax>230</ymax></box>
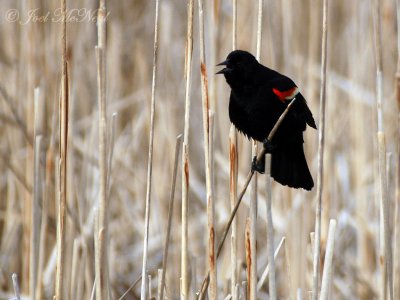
<box><xmin>320</xmin><ymin>219</ymin><xmax>336</xmax><ymax>300</ymax></box>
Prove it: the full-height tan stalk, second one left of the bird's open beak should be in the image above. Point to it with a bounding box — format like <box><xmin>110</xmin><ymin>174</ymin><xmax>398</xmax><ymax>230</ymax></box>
<box><xmin>181</xmin><ymin>0</ymin><xmax>193</xmax><ymax>299</ymax></box>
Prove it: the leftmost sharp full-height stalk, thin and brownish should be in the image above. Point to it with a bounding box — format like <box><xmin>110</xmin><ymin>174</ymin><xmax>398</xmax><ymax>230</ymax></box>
<box><xmin>55</xmin><ymin>0</ymin><xmax>69</xmax><ymax>300</ymax></box>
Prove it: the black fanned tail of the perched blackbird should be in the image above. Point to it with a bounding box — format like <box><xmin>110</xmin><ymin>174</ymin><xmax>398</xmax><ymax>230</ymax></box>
<box><xmin>271</xmin><ymin>142</ymin><xmax>314</xmax><ymax>191</ymax></box>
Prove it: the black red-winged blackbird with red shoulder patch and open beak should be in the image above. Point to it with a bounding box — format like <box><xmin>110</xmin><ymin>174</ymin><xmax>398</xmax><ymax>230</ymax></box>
<box><xmin>217</xmin><ymin>50</ymin><xmax>317</xmax><ymax>190</ymax></box>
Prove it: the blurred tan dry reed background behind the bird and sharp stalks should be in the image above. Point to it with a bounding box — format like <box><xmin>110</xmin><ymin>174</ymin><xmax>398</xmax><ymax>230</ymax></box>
<box><xmin>0</xmin><ymin>0</ymin><xmax>400</xmax><ymax>299</ymax></box>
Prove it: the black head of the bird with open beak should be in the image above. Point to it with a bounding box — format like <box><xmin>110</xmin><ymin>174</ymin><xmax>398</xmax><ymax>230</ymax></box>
<box><xmin>217</xmin><ymin>50</ymin><xmax>258</xmax><ymax>87</ymax></box>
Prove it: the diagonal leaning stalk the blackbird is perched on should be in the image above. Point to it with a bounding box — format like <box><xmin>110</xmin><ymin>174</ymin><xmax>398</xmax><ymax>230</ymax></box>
<box><xmin>198</xmin><ymin>98</ymin><xmax>296</xmax><ymax>299</ymax></box>
